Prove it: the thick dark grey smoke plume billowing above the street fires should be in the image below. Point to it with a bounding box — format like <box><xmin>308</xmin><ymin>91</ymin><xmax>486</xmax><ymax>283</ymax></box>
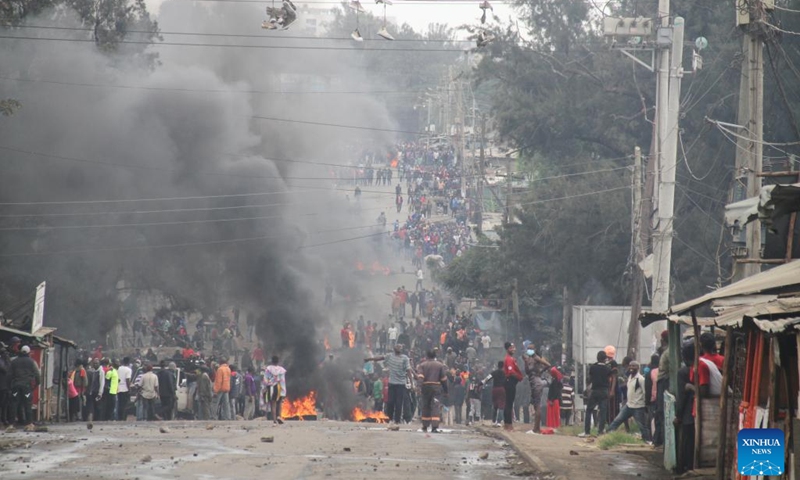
<box><xmin>0</xmin><ymin>1</ymin><xmax>410</xmax><ymax>396</ymax></box>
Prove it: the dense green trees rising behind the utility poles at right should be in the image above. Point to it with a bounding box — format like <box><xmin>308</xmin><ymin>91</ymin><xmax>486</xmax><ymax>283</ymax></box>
<box><xmin>441</xmin><ymin>0</ymin><xmax>800</xmax><ymax>346</ymax></box>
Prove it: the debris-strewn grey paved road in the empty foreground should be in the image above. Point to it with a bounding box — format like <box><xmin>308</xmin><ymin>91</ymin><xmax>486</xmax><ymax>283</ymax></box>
<box><xmin>0</xmin><ymin>420</ymin><xmax>524</xmax><ymax>480</ymax></box>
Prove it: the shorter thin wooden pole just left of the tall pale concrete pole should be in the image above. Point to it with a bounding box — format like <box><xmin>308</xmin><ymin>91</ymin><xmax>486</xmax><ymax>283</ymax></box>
<box><xmin>627</xmin><ymin>147</ymin><xmax>644</xmax><ymax>359</ymax></box>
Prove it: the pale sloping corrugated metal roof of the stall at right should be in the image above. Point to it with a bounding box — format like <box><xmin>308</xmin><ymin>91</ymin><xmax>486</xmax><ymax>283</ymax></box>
<box><xmin>669</xmin><ymin>261</ymin><xmax>800</xmax><ymax>315</ymax></box>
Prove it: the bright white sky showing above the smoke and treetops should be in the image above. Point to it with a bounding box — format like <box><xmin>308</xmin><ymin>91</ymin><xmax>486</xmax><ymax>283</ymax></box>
<box><xmin>145</xmin><ymin>0</ymin><xmax>516</xmax><ymax>39</ymax></box>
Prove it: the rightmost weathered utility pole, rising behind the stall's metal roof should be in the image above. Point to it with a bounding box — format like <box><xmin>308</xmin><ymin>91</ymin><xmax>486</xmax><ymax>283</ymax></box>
<box><xmin>733</xmin><ymin>0</ymin><xmax>773</xmax><ymax>282</ymax></box>
